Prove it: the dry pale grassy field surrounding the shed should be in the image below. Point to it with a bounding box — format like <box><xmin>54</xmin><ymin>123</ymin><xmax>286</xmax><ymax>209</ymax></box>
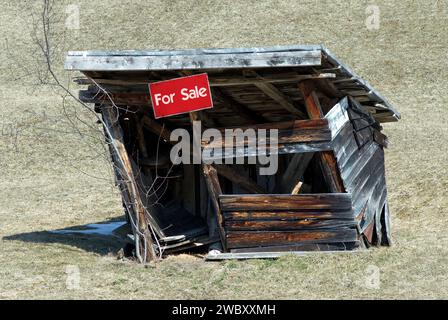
<box><xmin>0</xmin><ymin>0</ymin><xmax>448</xmax><ymax>299</ymax></box>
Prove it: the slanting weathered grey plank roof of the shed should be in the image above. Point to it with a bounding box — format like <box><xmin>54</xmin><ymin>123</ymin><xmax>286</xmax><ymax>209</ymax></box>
<box><xmin>65</xmin><ymin>45</ymin><xmax>400</xmax><ymax>122</ymax></box>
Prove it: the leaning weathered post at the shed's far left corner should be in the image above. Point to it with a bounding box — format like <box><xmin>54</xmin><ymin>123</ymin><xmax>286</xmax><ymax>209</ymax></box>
<box><xmin>101</xmin><ymin>107</ymin><xmax>157</xmax><ymax>263</ymax></box>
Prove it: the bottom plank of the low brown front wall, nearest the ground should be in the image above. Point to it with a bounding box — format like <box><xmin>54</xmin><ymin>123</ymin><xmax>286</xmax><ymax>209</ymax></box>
<box><xmin>226</xmin><ymin>228</ymin><xmax>358</xmax><ymax>249</ymax></box>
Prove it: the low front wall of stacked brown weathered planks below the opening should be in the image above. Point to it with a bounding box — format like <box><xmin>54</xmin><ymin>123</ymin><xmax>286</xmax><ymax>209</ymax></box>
<box><xmin>219</xmin><ymin>193</ymin><xmax>358</xmax><ymax>251</ymax></box>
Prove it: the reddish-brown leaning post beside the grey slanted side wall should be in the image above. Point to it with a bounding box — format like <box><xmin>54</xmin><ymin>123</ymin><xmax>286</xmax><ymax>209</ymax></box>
<box><xmin>299</xmin><ymin>80</ymin><xmax>345</xmax><ymax>193</ymax></box>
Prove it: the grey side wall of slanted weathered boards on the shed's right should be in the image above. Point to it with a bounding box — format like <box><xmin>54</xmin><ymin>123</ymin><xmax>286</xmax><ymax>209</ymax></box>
<box><xmin>333</xmin><ymin>101</ymin><xmax>390</xmax><ymax>245</ymax></box>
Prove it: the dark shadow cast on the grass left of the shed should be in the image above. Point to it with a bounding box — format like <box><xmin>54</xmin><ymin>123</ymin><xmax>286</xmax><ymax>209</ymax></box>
<box><xmin>3</xmin><ymin>219</ymin><xmax>128</xmax><ymax>255</ymax></box>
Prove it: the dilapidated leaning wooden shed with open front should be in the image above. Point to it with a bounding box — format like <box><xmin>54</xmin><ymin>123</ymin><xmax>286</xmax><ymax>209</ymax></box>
<box><xmin>65</xmin><ymin>46</ymin><xmax>400</xmax><ymax>262</ymax></box>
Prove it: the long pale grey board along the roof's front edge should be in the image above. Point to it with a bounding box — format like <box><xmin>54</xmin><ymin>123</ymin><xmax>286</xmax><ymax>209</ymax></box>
<box><xmin>64</xmin><ymin>50</ymin><xmax>321</xmax><ymax>71</ymax></box>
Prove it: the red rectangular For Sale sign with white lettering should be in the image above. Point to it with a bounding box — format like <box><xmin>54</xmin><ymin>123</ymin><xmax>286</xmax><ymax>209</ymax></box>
<box><xmin>149</xmin><ymin>73</ymin><xmax>213</xmax><ymax>119</ymax></box>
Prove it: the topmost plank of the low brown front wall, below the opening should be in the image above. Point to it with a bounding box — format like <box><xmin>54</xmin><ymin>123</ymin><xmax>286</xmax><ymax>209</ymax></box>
<box><xmin>219</xmin><ymin>193</ymin><xmax>352</xmax><ymax>211</ymax></box>
